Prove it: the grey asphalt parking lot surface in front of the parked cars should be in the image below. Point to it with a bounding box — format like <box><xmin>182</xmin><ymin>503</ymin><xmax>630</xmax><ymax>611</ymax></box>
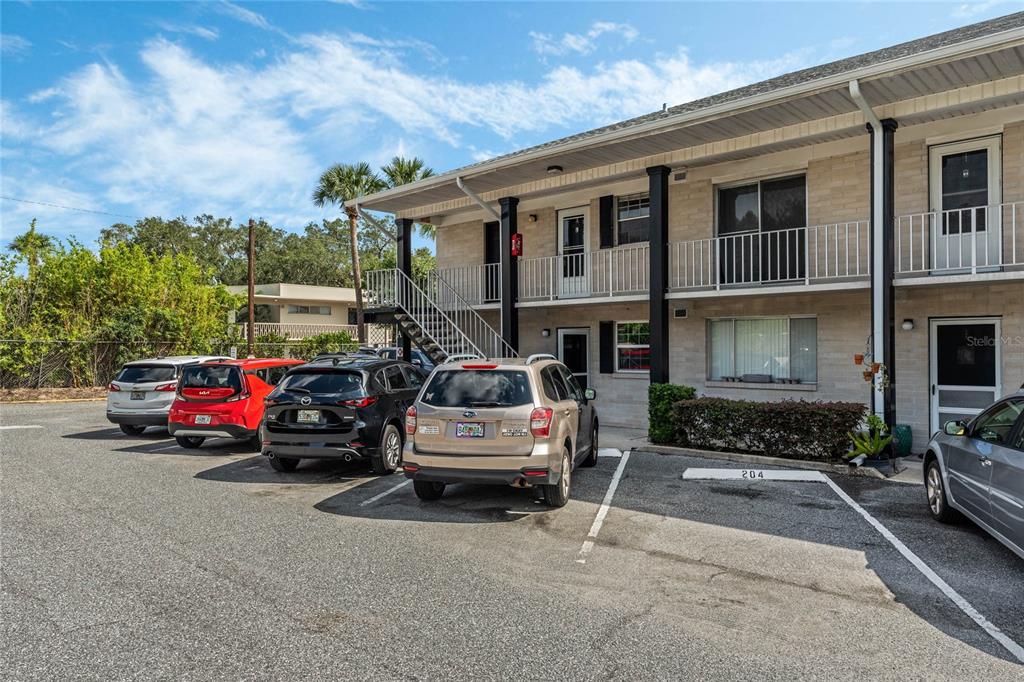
<box><xmin>6</xmin><ymin>402</ymin><xmax>1024</xmax><ymax>680</ymax></box>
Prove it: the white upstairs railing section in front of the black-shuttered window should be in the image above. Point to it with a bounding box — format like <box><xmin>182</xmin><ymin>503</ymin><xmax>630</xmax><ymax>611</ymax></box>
<box><xmin>519</xmin><ymin>244</ymin><xmax>650</xmax><ymax>301</ymax></box>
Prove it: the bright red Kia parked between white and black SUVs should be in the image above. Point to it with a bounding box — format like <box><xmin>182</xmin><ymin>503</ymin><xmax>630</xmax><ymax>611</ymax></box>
<box><xmin>167</xmin><ymin>357</ymin><xmax>303</xmax><ymax>450</ymax></box>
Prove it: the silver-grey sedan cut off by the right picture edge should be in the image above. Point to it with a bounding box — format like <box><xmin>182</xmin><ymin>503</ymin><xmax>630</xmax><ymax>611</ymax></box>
<box><xmin>924</xmin><ymin>390</ymin><xmax>1024</xmax><ymax>558</ymax></box>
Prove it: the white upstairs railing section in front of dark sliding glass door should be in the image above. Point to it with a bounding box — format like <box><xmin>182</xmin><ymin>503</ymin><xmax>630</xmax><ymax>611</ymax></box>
<box><xmin>669</xmin><ymin>220</ymin><xmax>870</xmax><ymax>290</ymax></box>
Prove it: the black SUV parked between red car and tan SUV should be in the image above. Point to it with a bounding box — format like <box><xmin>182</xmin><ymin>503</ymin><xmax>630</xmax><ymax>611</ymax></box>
<box><xmin>261</xmin><ymin>355</ymin><xmax>426</xmax><ymax>474</ymax></box>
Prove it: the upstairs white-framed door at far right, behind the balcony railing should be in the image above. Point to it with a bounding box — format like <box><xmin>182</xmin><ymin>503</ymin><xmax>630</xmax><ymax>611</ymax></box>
<box><xmin>929</xmin><ymin>136</ymin><xmax>1002</xmax><ymax>274</ymax></box>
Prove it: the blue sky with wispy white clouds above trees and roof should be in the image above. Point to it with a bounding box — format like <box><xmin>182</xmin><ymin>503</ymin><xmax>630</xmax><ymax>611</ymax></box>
<box><xmin>0</xmin><ymin>0</ymin><xmax>1024</xmax><ymax>245</ymax></box>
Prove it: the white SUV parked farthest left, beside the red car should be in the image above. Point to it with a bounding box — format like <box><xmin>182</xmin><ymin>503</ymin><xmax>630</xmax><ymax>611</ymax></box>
<box><xmin>106</xmin><ymin>355</ymin><xmax>230</xmax><ymax>435</ymax></box>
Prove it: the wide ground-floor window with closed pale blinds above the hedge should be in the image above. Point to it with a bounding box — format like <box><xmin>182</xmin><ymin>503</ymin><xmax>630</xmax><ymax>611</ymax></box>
<box><xmin>708</xmin><ymin>317</ymin><xmax>818</xmax><ymax>383</ymax></box>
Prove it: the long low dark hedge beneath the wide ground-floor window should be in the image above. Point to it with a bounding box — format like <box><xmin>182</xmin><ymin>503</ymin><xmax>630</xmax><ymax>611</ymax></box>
<box><xmin>673</xmin><ymin>397</ymin><xmax>864</xmax><ymax>460</ymax></box>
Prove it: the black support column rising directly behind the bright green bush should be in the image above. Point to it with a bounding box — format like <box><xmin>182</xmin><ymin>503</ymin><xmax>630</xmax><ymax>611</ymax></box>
<box><xmin>647</xmin><ymin>166</ymin><xmax>672</xmax><ymax>384</ymax></box>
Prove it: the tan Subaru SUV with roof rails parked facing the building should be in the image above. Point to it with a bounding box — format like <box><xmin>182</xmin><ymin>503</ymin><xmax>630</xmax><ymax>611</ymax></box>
<box><xmin>402</xmin><ymin>354</ymin><xmax>597</xmax><ymax>507</ymax></box>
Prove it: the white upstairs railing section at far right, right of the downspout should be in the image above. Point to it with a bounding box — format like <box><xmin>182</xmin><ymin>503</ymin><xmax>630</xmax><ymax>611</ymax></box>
<box><xmin>896</xmin><ymin>202</ymin><xmax>1024</xmax><ymax>275</ymax></box>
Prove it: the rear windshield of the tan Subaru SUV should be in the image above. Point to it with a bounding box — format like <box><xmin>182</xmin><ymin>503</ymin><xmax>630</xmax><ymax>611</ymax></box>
<box><xmin>422</xmin><ymin>370</ymin><xmax>534</xmax><ymax>408</ymax></box>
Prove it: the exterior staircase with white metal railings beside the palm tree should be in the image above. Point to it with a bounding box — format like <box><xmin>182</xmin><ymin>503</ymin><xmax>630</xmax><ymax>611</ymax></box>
<box><xmin>365</xmin><ymin>268</ymin><xmax>517</xmax><ymax>364</ymax></box>
